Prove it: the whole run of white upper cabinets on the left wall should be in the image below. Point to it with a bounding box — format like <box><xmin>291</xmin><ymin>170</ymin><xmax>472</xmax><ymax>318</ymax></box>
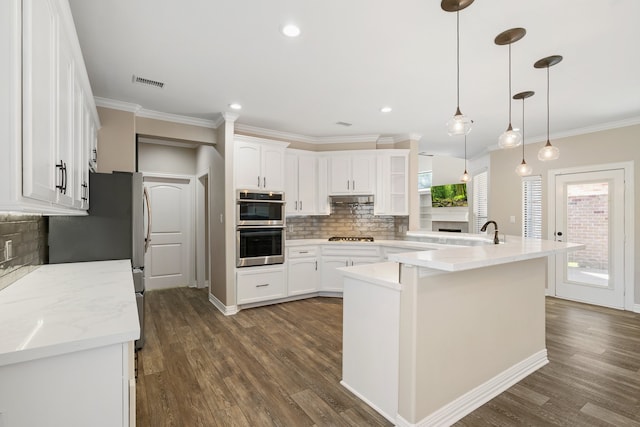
<box><xmin>0</xmin><ymin>0</ymin><xmax>98</xmax><ymax>214</ymax></box>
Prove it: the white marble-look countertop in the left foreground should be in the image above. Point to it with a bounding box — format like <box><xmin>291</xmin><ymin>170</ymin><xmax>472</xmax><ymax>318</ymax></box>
<box><xmin>0</xmin><ymin>260</ymin><xmax>140</xmax><ymax>366</ymax></box>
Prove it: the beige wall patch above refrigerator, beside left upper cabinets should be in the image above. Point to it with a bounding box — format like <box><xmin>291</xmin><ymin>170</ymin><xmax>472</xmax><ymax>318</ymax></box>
<box><xmin>98</xmin><ymin>107</ymin><xmax>136</xmax><ymax>173</ymax></box>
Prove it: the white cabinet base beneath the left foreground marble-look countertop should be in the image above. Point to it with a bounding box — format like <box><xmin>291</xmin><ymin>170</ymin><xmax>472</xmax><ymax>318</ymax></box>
<box><xmin>0</xmin><ymin>342</ymin><xmax>136</xmax><ymax>427</ymax></box>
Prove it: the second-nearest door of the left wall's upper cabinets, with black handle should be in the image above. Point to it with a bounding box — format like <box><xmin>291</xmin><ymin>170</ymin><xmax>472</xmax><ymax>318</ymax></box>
<box><xmin>54</xmin><ymin>26</ymin><xmax>77</xmax><ymax>206</ymax></box>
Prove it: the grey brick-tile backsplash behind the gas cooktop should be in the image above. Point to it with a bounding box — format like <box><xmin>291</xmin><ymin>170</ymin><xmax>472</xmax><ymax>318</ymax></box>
<box><xmin>287</xmin><ymin>205</ymin><xmax>409</xmax><ymax>240</ymax></box>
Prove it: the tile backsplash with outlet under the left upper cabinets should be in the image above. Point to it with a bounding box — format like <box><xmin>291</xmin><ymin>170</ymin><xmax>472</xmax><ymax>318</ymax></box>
<box><xmin>0</xmin><ymin>213</ymin><xmax>47</xmax><ymax>289</ymax></box>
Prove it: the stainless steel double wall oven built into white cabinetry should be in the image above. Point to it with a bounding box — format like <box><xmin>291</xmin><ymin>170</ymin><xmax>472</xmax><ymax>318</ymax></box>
<box><xmin>236</xmin><ymin>190</ymin><xmax>285</xmax><ymax>267</ymax></box>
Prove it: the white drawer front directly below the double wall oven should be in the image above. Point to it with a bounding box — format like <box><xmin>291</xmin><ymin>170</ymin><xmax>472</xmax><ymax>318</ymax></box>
<box><xmin>236</xmin><ymin>264</ymin><xmax>287</xmax><ymax>305</ymax></box>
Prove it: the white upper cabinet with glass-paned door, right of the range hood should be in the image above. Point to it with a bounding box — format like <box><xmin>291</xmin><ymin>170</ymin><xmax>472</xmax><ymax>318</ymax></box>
<box><xmin>373</xmin><ymin>150</ymin><xmax>409</xmax><ymax>215</ymax></box>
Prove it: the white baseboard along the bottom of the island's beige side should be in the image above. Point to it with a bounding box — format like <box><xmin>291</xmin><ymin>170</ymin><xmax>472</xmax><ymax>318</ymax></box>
<box><xmin>395</xmin><ymin>349</ymin><xmax>549</xmax><ymax>427</ymax></box>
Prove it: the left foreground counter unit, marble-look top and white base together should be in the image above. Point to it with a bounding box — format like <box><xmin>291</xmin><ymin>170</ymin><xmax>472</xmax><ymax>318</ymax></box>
<box><xmin>0</xmin><ymin>260</ymin><xmax>140</xmax><ymax>427</ymax></box>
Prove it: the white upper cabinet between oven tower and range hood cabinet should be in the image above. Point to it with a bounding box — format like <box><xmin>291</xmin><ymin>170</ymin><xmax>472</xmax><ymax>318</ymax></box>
<box><xmin>284</xmin><ymin>150</ymin><xmax>318</xmax><ymax>215</ymax></box>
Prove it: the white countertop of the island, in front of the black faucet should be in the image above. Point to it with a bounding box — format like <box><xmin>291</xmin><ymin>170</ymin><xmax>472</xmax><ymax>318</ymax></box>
<box><xmin>389</xmin><ymin>236</ymin><xmax>585</xmax><ymax>271</ymax></box>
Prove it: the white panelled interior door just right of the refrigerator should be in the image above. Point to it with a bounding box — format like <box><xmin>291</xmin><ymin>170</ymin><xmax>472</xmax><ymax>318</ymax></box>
<box><xmin>144</xmin><ymin>176</ymin><xmax>195</xmax><ymax>290</ymax></box>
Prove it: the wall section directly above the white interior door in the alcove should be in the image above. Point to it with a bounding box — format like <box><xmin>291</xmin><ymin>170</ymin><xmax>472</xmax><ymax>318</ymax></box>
<box><xmin>138</xmin><ymin>143</ymin><xmax>197</xmax><ymax>175</ymax></box>
